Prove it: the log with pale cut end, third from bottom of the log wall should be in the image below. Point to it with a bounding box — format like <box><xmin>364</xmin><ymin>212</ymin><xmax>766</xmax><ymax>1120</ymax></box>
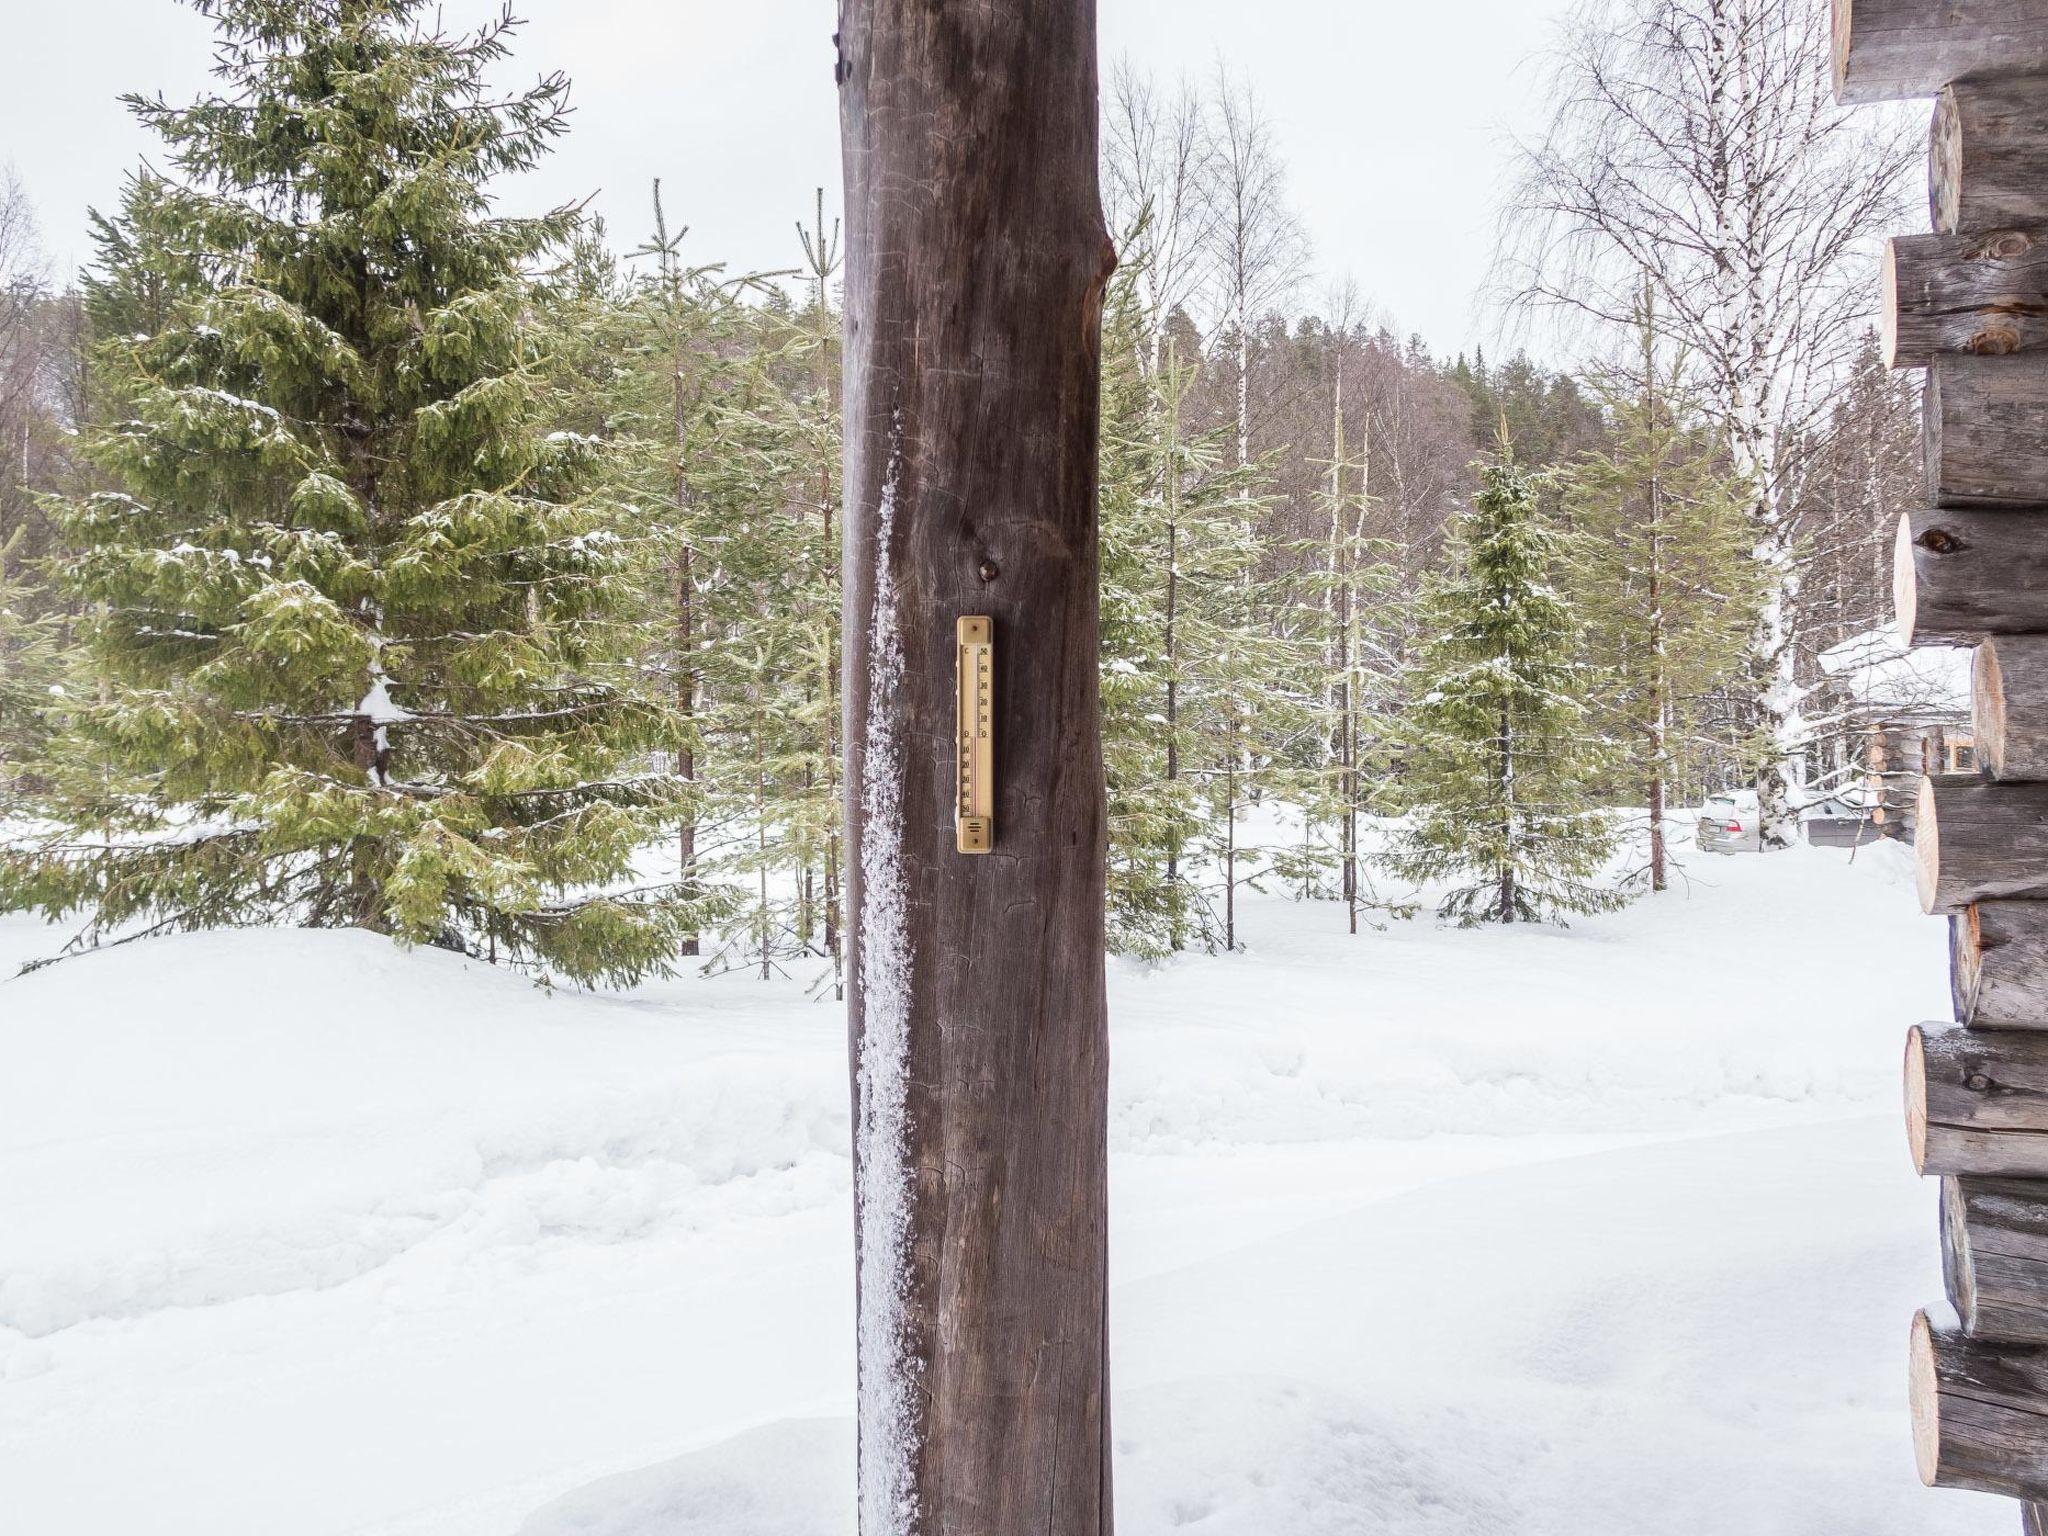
<box><xmin>1905</xmin><ymin>1024</ymin><xmax>2048</xmax><ymax>1178</ymax></box>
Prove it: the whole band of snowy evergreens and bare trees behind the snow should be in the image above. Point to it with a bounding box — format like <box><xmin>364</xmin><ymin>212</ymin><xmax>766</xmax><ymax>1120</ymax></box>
<box><xmin>0</xmin><ymin>0</ymin><xmax>1915</xmax><ymax>985</ymax></box>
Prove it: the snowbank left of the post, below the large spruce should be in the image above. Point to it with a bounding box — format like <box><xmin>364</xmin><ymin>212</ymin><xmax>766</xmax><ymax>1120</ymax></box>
<box><xmin>0</xmin><ymin>930</ymin><xmax>846</xmax><ymax>1337</ymax></box>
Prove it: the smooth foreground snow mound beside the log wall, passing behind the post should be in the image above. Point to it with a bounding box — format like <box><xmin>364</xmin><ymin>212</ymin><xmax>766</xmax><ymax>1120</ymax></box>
<box><xmin>520</xmin><ymin>1118</ymin><xmax>2009</xmax><ymax>1536</ymax></box>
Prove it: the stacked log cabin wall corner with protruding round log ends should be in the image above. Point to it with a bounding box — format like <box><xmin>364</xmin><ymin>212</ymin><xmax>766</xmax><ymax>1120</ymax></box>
<box><xmin>1833</xmin><ymin>0</ymin><xmax>2048</xmax><ymax>1536</ymax></box>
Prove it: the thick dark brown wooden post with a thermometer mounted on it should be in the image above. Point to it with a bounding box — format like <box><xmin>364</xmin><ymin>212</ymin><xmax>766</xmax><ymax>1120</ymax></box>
<box><xmin>838</xmin><ymin>0</ymin><xmax>1114</xmax><ymax>1536</ymax></box>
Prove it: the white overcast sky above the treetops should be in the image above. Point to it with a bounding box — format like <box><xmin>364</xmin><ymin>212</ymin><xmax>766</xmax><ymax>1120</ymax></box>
<box><xmin>0</xmin><ymin>0</ymin><xmax>1569</xmax><ymax>350</ymax></box>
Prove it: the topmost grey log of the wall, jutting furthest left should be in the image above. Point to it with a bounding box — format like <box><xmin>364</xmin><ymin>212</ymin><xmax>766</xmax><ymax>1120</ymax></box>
<box><xmin>1833</xmin><ymin>0</ymin><xmax>2048</xmax><ymax>102</ymax></box>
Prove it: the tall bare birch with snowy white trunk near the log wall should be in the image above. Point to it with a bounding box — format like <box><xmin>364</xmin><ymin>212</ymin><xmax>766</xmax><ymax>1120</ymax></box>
<box><xmin>1501</xmin><ymin>0</ymin><xmax>1915</xmax><ymax>846</ymax></box>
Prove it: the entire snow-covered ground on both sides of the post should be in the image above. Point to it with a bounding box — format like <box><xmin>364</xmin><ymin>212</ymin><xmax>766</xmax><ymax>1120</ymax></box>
<box><xmin>0</xmin><ymin>846</ymin><xmax>2015</xmax><ymax>1536</ymax></box>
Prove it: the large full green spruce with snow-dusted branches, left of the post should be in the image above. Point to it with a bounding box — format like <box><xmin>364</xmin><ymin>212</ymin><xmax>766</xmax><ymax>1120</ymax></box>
<box><xmin>0</xmin><ymin>0</ymin><xmax>676</xmax><ymax>981</ymax></box>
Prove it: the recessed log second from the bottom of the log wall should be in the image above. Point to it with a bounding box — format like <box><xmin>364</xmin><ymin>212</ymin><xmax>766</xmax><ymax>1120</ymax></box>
<box><xmin>1942</xmin><ymin>1176</ymin><xmax>2048</xmax><ymax>1343</ymax></box>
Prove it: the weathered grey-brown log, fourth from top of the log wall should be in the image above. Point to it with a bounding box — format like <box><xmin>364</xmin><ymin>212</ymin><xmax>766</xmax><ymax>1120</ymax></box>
<box><xmin>1921</xmin><ymin>354</ymin><xmax>2048</xmax><ymax>508</ymax></box>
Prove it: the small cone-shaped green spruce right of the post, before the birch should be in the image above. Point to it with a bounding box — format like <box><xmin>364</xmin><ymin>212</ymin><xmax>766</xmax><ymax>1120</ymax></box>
<box><xmin>1389</xmin><ymin>463</ymin><xmax>1622</xmax><ymax>924</ymax></box>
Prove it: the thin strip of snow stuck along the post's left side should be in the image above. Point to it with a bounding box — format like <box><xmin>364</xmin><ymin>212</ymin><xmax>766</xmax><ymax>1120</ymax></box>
<box><xmin>854</xmin><ymin>440</ymin><xmax>918</xmax><ymax>1536</ymax></box>
